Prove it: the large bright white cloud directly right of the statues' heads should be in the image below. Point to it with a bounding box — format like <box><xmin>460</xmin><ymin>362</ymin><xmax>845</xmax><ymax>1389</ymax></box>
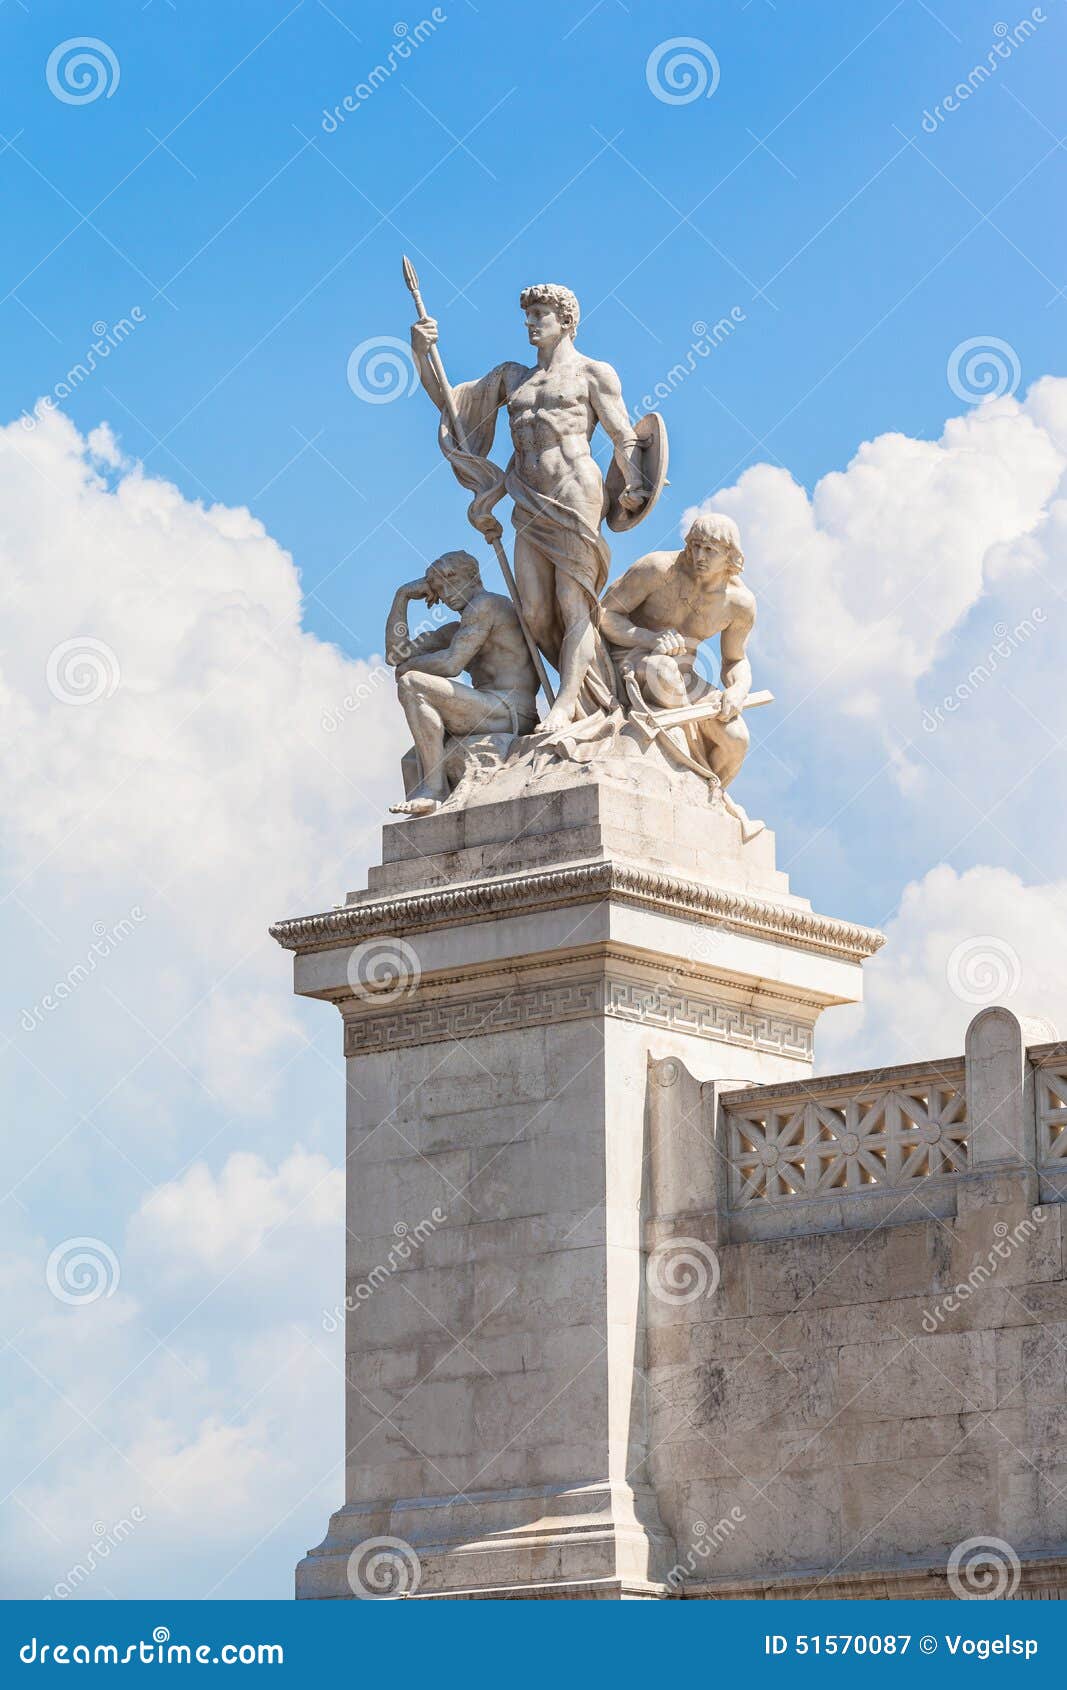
<box><xmin>683</xmin><ymin>377</ymin><xmax>1067</xmax><ymax>717</ymax></box>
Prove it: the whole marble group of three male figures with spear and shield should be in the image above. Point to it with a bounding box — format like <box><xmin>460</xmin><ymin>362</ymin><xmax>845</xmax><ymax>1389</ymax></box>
<box><xmin>386</xmin><ymin>260</ymin><xmax>771</xmax><ymax>838</ymax></box>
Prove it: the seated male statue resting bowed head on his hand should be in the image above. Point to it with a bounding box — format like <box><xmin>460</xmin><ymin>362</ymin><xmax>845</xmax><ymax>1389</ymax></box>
<box><xmin>386</xmin><ymin>551</ymin><xmax>538</xmax><ymax>816</ymax></box>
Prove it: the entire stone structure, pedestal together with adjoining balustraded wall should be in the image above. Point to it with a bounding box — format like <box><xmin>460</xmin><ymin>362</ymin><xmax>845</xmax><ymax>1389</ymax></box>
<box><xmin>274</xmin><ymin>766</ymin><xmax>1067</xmax><ymax>1600</ymax></box>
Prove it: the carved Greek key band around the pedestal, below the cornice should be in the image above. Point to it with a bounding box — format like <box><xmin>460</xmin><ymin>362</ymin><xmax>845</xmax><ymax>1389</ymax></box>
<box><xmin>345</xmin><ymin>979</ymin><xmax>812</xmax><ymax>1061</ymax></box>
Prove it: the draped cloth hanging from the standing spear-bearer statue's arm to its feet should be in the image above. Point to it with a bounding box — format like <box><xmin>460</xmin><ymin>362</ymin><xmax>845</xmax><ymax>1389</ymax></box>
<box><xmin>438</xmin><ymin>363</ymin><xmax>622</xmax><ymax>708</ymax></box>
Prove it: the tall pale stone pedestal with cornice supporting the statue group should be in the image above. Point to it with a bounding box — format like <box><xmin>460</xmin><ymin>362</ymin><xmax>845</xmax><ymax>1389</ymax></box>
<box><xmin>272</xmin><ymin>764</ymin><xmax>879</xmax><ymax>1599</ymax></box>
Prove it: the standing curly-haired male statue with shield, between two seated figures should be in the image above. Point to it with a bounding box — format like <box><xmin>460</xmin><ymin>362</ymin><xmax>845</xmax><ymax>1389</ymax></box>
<box><xmin>411</xmin><ymin>282</ymin><xmax>649</xmax><ymax>733</ymax></box>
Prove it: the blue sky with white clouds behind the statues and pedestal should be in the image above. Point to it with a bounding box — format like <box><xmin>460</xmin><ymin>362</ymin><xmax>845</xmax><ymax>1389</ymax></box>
<box><xmin>0</xmin><ymin>0</ymin><xmax>1067</xmax><ymax>1595</ymax></box>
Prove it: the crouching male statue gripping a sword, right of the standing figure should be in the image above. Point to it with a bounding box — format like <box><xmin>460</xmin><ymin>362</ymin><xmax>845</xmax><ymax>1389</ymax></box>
<box><xmin>600</xmin><ymin>514</ymin><xmax>766</xmax><ymax>797</ymax></box>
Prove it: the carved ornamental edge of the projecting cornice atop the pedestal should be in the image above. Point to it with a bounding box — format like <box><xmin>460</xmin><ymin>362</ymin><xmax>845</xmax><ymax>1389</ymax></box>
<box><xmin>271</xmin><ymin>862</ymin><xmax>884</xmax><ymax>962</ymax></box>
